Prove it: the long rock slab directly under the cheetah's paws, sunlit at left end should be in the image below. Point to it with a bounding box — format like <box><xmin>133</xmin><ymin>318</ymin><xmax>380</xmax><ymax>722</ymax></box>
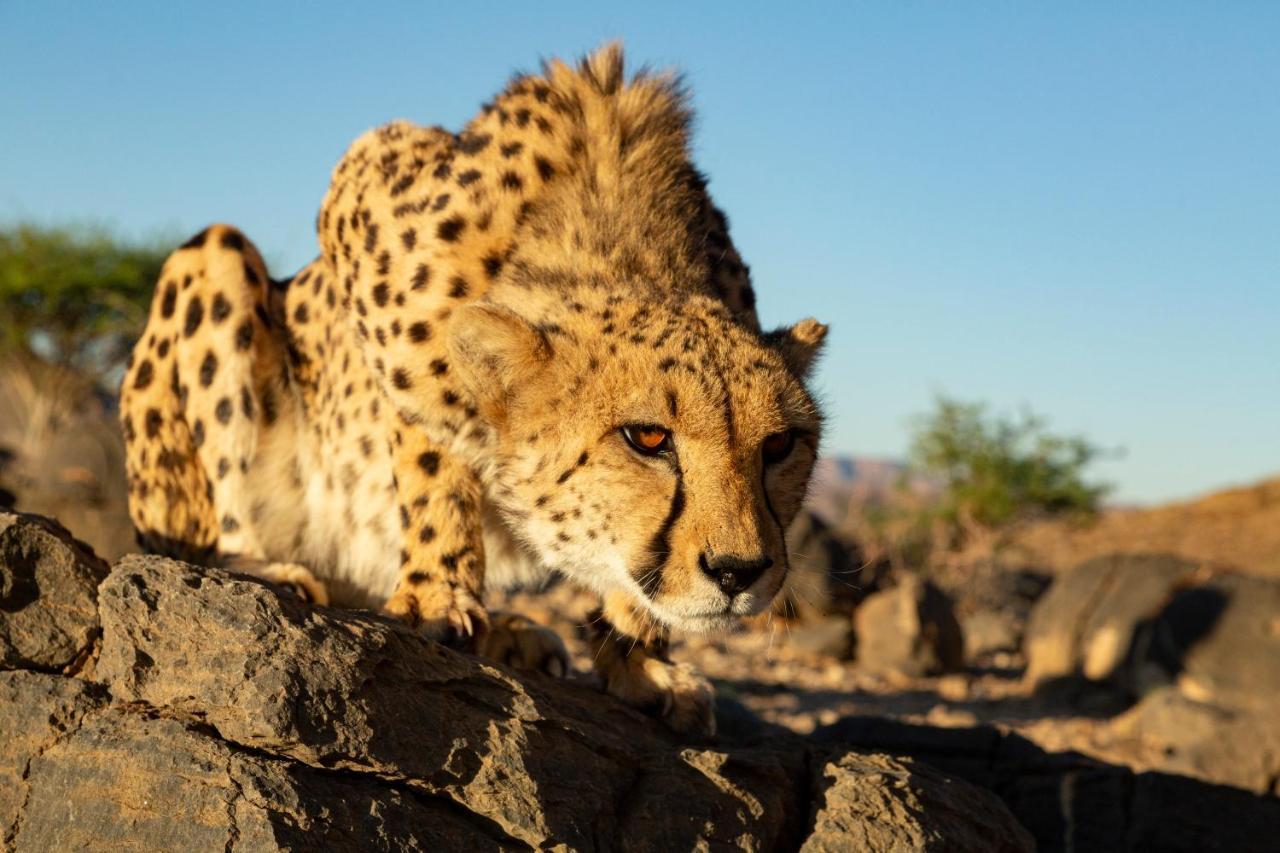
<box><xmin>96</xmin><ymin>557</ymin><xmax>803</xmax><ymax>849</ymax></box>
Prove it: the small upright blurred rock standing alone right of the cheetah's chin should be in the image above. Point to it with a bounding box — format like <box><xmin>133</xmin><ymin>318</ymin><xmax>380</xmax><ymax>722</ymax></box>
<box><xmin>854</xmin><ymin>574</ymin><xmax>964</xmax><ymax>678</ymax></box>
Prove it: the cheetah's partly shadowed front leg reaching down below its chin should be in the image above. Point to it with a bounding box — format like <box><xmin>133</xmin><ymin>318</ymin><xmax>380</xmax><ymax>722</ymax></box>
<box><xmin>588</xmin><ymin>593</ymin><xmax>716</xmax><ymax>736</ymax></box>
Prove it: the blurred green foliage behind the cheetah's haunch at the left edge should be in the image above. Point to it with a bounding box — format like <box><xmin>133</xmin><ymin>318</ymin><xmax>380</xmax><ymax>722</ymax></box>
<box><xmin>0</xmin><ymin>224</ymin><xmax>168</xmax><ymax>374</ymax></box>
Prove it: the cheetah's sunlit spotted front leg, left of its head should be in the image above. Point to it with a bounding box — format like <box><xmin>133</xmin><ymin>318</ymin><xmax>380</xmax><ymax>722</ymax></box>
<box><xmin>384</xmin><ymin>421</ymin><xmax>489</xmax><ymax>647</ymax></box>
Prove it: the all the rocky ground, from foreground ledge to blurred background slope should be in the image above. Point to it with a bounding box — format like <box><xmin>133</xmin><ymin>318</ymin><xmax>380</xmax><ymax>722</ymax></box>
<box><xmin>0</xmin><ymin>373</ymin><xmax>1280</xmax><ymax>850</ymax></box>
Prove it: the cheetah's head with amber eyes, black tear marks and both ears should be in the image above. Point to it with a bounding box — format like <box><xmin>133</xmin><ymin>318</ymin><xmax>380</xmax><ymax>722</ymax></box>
<box><xmin>452</xmin><ymin>295</ymin><xmax>826</xmax><ymax>630</ymax></box>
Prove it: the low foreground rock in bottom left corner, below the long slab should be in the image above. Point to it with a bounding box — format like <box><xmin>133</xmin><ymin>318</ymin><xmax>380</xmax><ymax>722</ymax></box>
<box><xmin>12</xmin><ymin>708</ymin><xmax>509</xmax><ymax>853</ymax></box>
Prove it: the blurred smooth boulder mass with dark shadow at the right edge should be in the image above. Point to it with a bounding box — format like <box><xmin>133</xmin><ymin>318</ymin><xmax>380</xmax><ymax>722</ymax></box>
<box><xmin>1028</xmin><ymin>555</ymin><xmax>1280</xmax><ymax>794</ymax></box>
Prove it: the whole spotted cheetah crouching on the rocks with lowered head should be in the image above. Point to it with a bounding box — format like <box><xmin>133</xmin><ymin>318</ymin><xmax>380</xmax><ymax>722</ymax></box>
<box><xmin>120</xmin><ymin>46</ymin><xmax>826</xmax><ymax>731</ymax></box>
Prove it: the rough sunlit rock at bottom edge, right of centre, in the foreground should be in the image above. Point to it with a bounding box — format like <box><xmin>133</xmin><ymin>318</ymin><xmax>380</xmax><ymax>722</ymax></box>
<box><xmin>800</xmin><ymin>752</ymin><xmax>1036</xmax><ymax>853</ymax></box>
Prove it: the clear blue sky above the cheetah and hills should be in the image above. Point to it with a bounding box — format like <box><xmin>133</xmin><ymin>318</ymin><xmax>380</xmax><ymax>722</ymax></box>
<box><xmin>0</xmin><ymin>0</ymin><xmax>1280</xmax><ymax>501</ymax></box>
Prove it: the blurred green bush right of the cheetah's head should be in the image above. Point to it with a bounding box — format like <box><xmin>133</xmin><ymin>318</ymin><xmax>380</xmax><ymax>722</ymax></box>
<box><xmin>910</xmin><ymin>397</ymin><xmax>1111</xmax><ymax>543</ymax></box>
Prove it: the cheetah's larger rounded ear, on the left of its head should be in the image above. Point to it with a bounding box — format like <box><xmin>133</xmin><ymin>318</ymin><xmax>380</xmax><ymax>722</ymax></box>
<box><xmin>449</xmin><ymin>305</ymin><xmax>552</xmax><ymax>418</ymax></box>
